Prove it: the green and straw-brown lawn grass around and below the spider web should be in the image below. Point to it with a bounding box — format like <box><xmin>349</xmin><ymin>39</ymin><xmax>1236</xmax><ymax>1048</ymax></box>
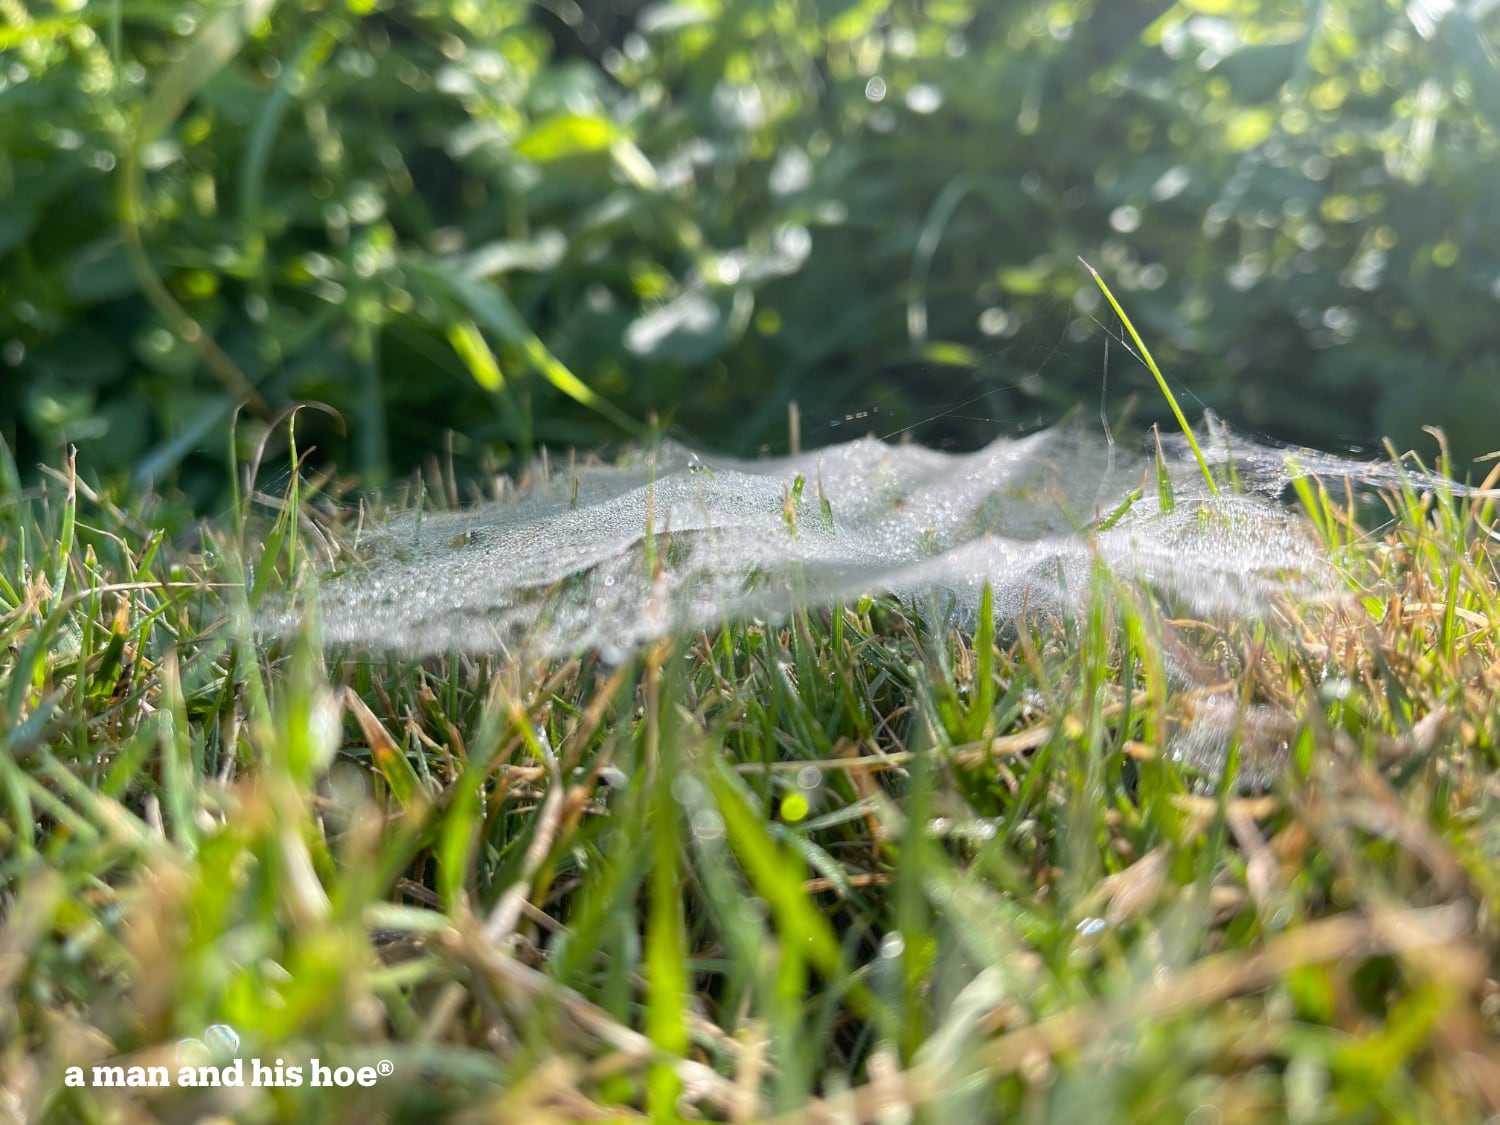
<box><xmin>0</xmin><ymin>426</ymin><xmax>1500</xmax><ymax>1125</ymax></box>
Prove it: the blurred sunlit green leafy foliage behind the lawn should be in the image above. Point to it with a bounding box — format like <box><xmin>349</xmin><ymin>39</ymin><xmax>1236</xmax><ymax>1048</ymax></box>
<box><xmin>0</xmin><ymin>0</ymin><xmax>1500</xmax><ymax>498</ymax></box>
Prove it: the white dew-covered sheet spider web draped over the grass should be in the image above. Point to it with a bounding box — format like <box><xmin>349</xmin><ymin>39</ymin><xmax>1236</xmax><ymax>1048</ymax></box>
<box><xmin>269</xmin><ymin>419</ymin><xmax>1476</xmax><ymax>774</ymax></box>
